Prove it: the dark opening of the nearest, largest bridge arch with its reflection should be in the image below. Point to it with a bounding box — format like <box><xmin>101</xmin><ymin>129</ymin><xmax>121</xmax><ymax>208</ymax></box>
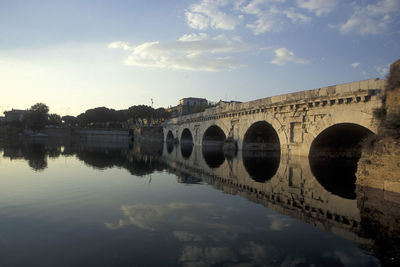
<box><xmin>309</xmin><ymin>123</ymin><xmax>374</xmax><ymax>199</ymax></box>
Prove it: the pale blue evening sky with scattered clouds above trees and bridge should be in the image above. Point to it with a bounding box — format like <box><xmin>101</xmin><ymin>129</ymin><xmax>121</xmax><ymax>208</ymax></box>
<box><xmin>0</xmin><ymin>0</ymin><xmax>400</xmax><ymax>116</ymax></box>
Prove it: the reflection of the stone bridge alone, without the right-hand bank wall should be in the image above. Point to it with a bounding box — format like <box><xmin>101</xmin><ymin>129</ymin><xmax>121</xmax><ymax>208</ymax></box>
<box><xmin>163</xmin><ymin>146</ymin><xmax>362</xmax><ymax>243</ymax></box>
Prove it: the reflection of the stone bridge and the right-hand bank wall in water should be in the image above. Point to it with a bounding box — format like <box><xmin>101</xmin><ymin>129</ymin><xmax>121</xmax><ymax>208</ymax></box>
<box><xmin>162</xmin><ymin>145</ymin><xmax>400</xmax><ymax>262</ymax></box>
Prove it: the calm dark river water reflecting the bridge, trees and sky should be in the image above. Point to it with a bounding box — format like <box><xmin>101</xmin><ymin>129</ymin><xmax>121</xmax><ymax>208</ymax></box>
<box><xmin>0</xmin><ymin>140</ymin><xmax>400</xmax><ymax>266</ymax></box>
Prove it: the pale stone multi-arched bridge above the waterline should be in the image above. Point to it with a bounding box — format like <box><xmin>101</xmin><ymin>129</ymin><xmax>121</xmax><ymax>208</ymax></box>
<box><xmin>163</xmin><ymin>79</ymin><xmax>386</xmax><ymax>156</ymax></box>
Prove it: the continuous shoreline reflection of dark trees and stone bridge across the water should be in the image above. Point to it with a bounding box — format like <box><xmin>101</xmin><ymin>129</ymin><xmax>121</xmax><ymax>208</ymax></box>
<box><xmin>0</xmin><ymin>142</ymin><xmax>400</xmax><ymax>264</ymax></box>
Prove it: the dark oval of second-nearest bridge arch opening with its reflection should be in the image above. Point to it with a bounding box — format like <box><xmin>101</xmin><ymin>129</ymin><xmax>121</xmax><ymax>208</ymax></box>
<box><xmin>243</xmin><ymin>121</ymin><xmax>281</xmax><ymax>183</ymax></box>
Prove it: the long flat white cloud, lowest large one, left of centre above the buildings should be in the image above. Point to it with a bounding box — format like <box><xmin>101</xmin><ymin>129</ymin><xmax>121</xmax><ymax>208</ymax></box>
<box><xmin>109</xmin><ymin>33</ymin><xmax>249</xmax><ymax>71</ymax></box>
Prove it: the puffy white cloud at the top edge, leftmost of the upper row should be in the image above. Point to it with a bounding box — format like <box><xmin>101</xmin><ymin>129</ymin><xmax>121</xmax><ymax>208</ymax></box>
<box><xmin>185</xmin><ymin>0</ymin><xmax>243</xmax><ymax>30</ymax></box>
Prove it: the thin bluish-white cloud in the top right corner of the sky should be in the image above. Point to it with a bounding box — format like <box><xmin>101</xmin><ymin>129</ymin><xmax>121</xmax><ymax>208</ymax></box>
<box><xmin>339</xmin><ymin>0</ymin><xmax>400</xmax><ymax>35</ymax></box>
